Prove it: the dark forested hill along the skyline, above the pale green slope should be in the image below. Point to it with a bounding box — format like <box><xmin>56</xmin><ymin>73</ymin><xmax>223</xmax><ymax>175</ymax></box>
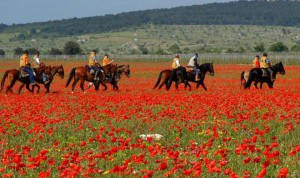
<box><xmin>0</xmin><ymin>1</ymin><xmax>300</xmax><ymax>38</ymax></box>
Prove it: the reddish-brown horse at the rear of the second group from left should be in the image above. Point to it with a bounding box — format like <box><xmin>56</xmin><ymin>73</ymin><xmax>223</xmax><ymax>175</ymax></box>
<box><xmin>66</xmin><ymin>66</ymin><xmax>107</xmax><ymax>93</ymax></box>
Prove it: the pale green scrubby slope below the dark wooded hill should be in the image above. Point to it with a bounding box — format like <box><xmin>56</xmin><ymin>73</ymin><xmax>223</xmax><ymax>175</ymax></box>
<box><xmin>0</xmin><ymin>25</ymin><xmax>300</xmax><ymax>54</ymax></box>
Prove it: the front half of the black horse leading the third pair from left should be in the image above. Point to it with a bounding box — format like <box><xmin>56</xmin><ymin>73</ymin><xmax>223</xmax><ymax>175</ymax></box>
<box><xmin>187</xmin><ymin>63</ymin><xmax>215</xmax><ymax>91</ymax></box>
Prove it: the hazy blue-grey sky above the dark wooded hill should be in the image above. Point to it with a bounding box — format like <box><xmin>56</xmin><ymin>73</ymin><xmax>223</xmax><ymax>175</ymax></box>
<box><xmin>0</xmin><ymin>0</ymin><xmax>229</xmax><ymax>25</ymax></box>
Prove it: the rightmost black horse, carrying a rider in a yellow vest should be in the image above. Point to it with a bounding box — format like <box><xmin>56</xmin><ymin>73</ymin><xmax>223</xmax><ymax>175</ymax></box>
<box><xmin>241</xmin><ymin>62</ymin><xmax>285</xmax><ymax>89</ymax></box>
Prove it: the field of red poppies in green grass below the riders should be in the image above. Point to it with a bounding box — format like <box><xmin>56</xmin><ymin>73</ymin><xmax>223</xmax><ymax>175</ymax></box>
<box><xmin>0</xmin><ymin>61</ymin><xmax>300</xmax><ymax>178</ymax></box>
